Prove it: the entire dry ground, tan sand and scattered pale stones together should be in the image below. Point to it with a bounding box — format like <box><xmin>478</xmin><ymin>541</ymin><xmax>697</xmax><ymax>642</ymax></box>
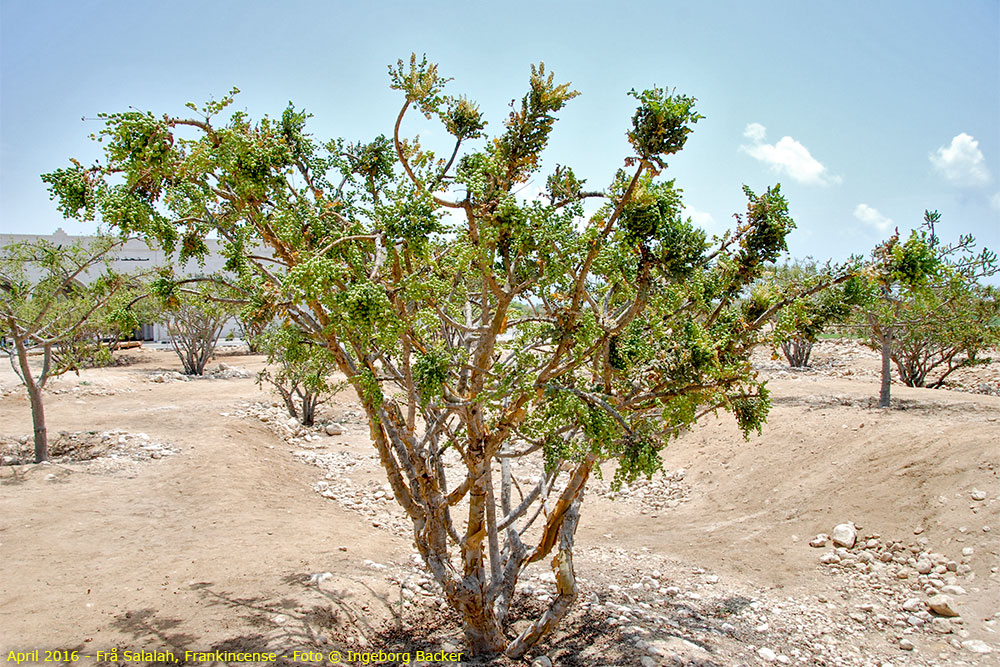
<box><xmin>0</xmin><ymin>341</ymin><xmax>1000</xmax><ymax>665</ymax></box>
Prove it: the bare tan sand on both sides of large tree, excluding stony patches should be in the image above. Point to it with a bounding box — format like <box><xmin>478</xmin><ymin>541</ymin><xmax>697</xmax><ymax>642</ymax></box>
<box><xmin>0</xmin><ymin>344</ymin><xmax>1000</xmax><ymax>664</ymax></box>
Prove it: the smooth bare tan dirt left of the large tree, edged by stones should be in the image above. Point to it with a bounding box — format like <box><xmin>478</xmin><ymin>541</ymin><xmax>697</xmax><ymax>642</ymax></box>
<box><xmin>0</xmin><ymin>354</ymin><xmax>407</xmax><ymax>654</ymax></box>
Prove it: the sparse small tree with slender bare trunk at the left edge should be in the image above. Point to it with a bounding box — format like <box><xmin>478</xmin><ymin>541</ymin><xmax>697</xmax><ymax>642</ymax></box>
<box><xmin>0</xmin><ymin>236</ymin><xmax>134</xmax><ymax>463</ymax></box>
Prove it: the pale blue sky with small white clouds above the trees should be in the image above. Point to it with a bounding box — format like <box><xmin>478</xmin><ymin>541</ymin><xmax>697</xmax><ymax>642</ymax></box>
<box><xmin>0</xmin><ymin>0</ymin><xmax>1000</xmax><ymax>266</ymax></box>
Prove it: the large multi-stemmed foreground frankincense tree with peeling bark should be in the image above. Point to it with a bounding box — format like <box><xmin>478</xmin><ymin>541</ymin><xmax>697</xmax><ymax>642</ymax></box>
<box><xmin>43</xmin><ymin>57</ymin><xmax>848</xmax><ymax>656</ymax></box>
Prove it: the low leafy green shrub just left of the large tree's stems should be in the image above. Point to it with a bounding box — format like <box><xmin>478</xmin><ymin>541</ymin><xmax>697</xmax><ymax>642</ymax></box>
<box><xmin>255</xmin><ymin>324</ymin><xmax>337</xmax><ymax>426</ymax></box>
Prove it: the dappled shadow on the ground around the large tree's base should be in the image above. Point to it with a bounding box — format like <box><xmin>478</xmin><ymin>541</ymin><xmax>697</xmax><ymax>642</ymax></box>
<box><xmin>101</xmin><ymin>573</ymin><xmax>759</xmax><ymax>667</ymax></box>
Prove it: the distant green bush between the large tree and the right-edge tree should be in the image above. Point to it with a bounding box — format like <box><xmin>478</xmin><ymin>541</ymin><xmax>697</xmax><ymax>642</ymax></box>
<box><xmin>770</xmin><ymin>260</ymin><xmax>867</xmax><ymax>368</ymax></box>
